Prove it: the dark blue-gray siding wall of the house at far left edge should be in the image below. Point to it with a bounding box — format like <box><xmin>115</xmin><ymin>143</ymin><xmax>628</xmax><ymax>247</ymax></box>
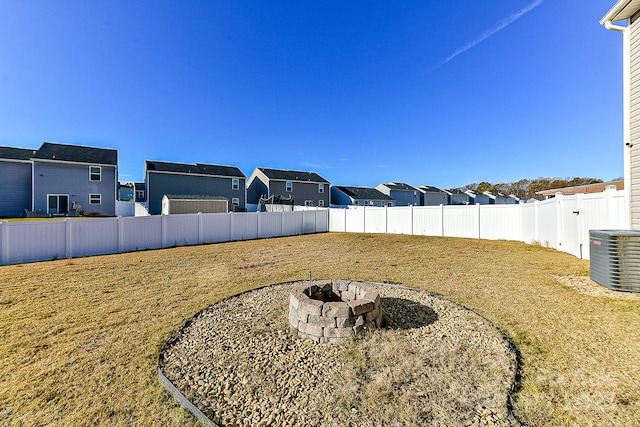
<box><xmin>0</xmin><ymin>161</ymin><xmax>31</xmax><ymax>217</ymax></box>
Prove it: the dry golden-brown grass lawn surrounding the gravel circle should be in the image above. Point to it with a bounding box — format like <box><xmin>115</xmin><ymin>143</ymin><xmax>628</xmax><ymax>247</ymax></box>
<box><xmin>0</xmin><ymin>233</ymin><xmax>640</xmax><ymax>426</ymax></box>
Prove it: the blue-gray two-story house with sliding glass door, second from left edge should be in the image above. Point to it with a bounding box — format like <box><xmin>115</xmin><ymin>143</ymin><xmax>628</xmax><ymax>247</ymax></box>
<box><xmin>31</xmin><ymin>142</ymin><xmax>118</xmax><ymax>216</ymax></box>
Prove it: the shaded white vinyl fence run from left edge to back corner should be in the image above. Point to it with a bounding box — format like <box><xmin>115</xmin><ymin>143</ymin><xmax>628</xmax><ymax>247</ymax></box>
<box><xmin>0</xmin><ymin>209</ymin><xmax>329</xmax><ymax>265</ymax></box>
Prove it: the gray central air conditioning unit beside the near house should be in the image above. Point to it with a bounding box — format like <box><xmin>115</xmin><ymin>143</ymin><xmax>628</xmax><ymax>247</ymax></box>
<box><xmin>589</xmin><ymin>230</ymin><xmax>640</xmax><ymax>292</ymax></box>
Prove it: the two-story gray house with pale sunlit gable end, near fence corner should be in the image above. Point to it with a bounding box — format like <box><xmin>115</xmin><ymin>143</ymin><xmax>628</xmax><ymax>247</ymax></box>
<box><xmin>247</xmin><ymin>168</ymin><xmax>330</xmax><ymax>207</ymax></box>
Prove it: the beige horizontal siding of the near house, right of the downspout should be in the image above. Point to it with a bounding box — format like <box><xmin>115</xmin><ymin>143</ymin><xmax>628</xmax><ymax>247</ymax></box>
<box><xmin>629</xmin><ymin>16</ymin><xmax>640</xmax><ymax>230</ymax></box>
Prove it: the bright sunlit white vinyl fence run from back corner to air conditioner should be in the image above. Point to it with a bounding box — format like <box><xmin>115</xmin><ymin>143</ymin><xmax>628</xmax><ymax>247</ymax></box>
<box><xmin>329</xmin><ymin>190</ymin><xmax>628</xmax><ymax>259</ymax></box>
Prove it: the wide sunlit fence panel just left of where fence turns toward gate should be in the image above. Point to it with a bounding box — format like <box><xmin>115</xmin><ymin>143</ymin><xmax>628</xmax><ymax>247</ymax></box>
<box><xmin>479</xmin><ymin>205</ymin><xmax>522</xmax><ymax>240</ymax></box>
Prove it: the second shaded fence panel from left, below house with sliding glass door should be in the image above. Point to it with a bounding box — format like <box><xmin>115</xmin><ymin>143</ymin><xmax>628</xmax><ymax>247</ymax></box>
<box><xmin>67</xmin><ymin>218</ymin><xmax>118</xmax><ymax>257</ymax></box>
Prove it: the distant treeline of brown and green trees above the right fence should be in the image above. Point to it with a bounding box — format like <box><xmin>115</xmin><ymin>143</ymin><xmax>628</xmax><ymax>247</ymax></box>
<box><xmin>463</xmin><ymin>177</ymin><xmax>604</xmax><ymax>199</ymax></box>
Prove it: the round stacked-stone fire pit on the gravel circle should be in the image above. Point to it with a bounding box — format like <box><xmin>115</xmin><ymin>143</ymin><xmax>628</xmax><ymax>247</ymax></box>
<box><xmin>289</xmin><ymin>280</ymin><xmax>382</xmax><ymax>343</ymax></box>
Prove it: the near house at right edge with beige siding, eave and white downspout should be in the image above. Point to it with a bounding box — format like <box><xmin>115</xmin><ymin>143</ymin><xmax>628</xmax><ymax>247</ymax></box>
<box><xmin>600</xmin><ymin>0</ymin><xmax>640</xmax><ymax>230</ymax></box>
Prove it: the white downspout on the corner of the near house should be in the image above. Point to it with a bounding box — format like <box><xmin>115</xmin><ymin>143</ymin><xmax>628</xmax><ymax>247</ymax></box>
<box><xmin>604</xmin><ymin>20</ymin><xmax>631</xmax><ymax>229</ymax></box>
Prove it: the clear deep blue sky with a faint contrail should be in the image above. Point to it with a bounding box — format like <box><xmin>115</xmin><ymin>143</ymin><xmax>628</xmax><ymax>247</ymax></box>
<box><xmin>0</xmin><ymin>0</ymin><xmax>623</xmax><ymax>188</ymax></box>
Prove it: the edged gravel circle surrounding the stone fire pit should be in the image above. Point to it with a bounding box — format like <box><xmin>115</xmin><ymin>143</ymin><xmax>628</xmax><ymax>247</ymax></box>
<box><xmin>160</xmin><ymin>283</ymin><xmax>520</xmax><ymax>427</ymax></box>
